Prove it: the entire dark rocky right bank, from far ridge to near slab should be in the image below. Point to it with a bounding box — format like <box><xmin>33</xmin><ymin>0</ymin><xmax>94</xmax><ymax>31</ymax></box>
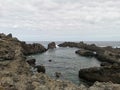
<box><xmin>59</xmin><ymin>42</ymin><xmax>120</xmax><ymax>84</ymax></box>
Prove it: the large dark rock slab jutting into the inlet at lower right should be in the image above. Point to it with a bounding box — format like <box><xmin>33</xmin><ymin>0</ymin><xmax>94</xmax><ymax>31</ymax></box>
<box><xmin>79</xmin><ymin>64</ymin><xmax>120</xmax><ymax>83</ymax></box>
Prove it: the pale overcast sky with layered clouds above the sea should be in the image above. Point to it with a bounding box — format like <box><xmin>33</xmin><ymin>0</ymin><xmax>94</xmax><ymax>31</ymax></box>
<box><xmin>0</xmin><ymin>0</ymin><xmax>120</xmax><ymax>41</ymax></box>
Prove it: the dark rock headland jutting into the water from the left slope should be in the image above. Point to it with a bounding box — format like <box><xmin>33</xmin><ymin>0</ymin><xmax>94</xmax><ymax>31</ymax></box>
<box><xmin>21</xmin><ymin>42</ymin><xmax>47</xmax><ymax>55</ymax></box>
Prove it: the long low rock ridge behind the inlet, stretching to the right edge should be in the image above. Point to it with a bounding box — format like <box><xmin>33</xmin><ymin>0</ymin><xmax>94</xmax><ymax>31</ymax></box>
<box><xmin>59</xmin><ymin>42</ymin><xmax>120</xmax><ymax>63</ymax></box>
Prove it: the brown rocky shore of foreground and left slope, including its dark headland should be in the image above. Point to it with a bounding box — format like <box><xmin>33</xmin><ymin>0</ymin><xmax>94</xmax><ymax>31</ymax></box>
<box><xmin>0</xmin><ymin>33</ymin><xmax>120</xmax><ymax>90</ymax></box>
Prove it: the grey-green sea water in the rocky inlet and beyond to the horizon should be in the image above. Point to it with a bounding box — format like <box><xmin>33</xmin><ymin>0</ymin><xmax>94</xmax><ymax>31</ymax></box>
<box><xmin>27</xmin><ymin>41</ymin><xmax>120</xmax><ymax>85</ymax></box>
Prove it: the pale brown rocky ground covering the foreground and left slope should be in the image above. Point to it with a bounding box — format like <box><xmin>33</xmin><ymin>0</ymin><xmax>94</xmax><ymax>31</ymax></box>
<box><xmin>0</xmin><ymin>34</ymin><xmax>120</xmax><ymax>90</ymax></box>
